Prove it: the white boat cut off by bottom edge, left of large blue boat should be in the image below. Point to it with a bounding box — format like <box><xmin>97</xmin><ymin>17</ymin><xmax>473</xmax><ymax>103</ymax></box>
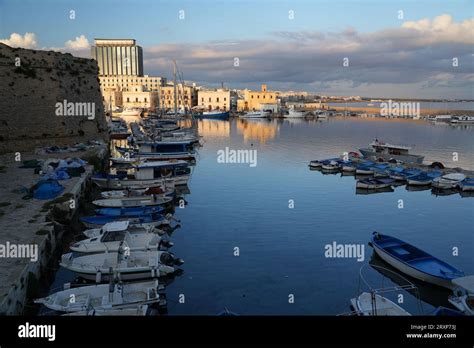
<box><xmin>351</xmin><ymin>292</ymin><xmax>411</xmax><ymax>316</ymax></box>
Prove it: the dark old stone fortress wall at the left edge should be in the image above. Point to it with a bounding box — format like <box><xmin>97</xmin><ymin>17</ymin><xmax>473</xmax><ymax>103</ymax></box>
<box><xmin>0</xmin><ymin>43</ymin><xmax>108</xmax><ymax>153</ymax></box>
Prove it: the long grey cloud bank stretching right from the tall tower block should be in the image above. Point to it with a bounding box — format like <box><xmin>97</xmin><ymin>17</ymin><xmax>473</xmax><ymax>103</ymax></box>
<box><xmin>144</xmin><ymin>14</ymin><xmax>474</xmax><ymax>98</ymax></box>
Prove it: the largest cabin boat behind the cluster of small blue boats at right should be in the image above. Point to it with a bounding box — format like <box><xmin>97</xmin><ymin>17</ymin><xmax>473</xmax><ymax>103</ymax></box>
<box><xmin>359</xmin><ymin>139</ymin><xmax>424</xmax><ymax>164</ymax></box>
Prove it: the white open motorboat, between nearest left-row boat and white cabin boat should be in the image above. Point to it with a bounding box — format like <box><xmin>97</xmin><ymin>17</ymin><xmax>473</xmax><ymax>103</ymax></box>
<box><xmin>60</xmin><ymin>249</ymin><xmax>184</xmax><ymax>283</ymax></box>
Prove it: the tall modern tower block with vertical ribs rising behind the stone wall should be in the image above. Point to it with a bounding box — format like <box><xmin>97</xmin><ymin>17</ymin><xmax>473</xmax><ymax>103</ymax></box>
<box><xmin>91</xmin><ymin>39</ymin><xmax>143</xmax><ymax>76</ymax></box>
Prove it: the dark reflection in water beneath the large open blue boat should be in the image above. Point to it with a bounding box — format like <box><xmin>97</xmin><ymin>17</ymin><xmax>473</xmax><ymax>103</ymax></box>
<box><xmin>369</xmin><ymin>252</ymin><xmax>451</xmax><ymax>307</ymax></box>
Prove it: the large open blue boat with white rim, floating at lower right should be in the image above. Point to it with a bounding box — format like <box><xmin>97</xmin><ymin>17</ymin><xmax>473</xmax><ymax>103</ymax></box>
<box><xmin>369</xmin><ymin>232</ymin><xmax>464</xmax><ymax>290</ymax></box>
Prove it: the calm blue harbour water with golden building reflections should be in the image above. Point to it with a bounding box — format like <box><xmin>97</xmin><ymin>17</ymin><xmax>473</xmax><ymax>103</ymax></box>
<box><xmin>49</xmin><ymin>118</ymin><xmax>474</xmax><ymax>315</ymax></box>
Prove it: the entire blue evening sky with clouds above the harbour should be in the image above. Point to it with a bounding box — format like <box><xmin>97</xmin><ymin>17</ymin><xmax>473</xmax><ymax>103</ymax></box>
<box><xmin>0</xmin><ymin>0</ymin><xmax>474</xmax><ymax>99</ymax></box>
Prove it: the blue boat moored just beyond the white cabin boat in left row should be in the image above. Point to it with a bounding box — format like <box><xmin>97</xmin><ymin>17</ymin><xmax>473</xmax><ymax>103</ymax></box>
<box><xmin>79</xmin><ymin>213</ymin><xmax>172</xmax><ymax>228</ymax></box>
